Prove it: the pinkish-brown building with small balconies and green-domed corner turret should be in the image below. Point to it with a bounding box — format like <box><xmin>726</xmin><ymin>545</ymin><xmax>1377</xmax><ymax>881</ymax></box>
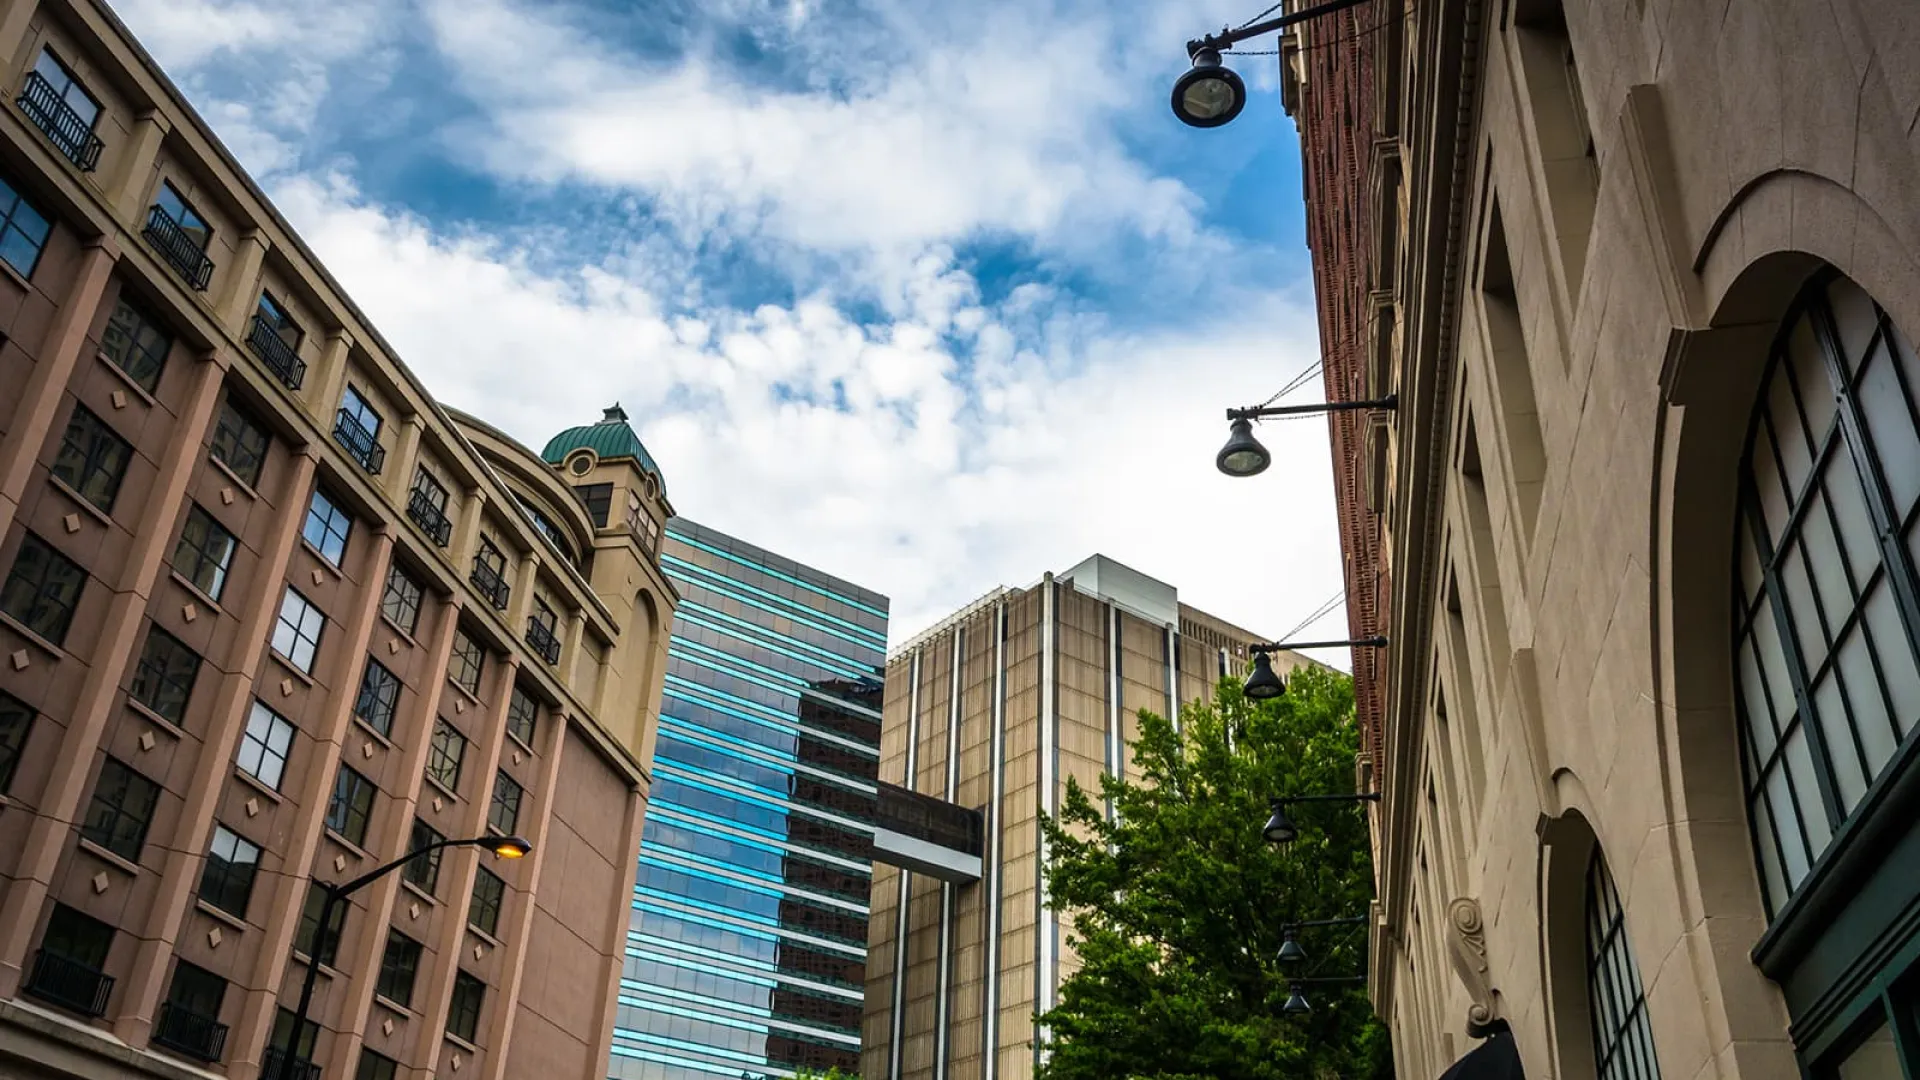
<box><xmin>0</xmin><ymin>0</ymin><xmax>674</xmax><ymax>1080</ymax></box>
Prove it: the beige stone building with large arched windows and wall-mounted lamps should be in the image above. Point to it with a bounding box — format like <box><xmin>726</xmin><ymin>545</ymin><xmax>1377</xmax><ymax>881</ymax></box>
<box><xmin>1286</xmin><ymin>0</ymin><xmax>1920</xmax><ymax>1080</ymax></box>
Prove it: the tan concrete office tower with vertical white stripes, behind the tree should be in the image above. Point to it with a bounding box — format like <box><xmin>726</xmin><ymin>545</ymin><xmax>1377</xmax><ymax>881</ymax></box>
<box><xmin>862</xmin><ymin>555</ymin><xmax>1309</xmax><ymax>1080</ymax></box>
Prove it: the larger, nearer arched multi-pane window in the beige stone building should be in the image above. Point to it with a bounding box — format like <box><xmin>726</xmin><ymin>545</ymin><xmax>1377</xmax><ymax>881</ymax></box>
<box><xmin>1734</xmin><ymin>275</ymin><xmax>1920</xmax><ymax>913</ymax></box>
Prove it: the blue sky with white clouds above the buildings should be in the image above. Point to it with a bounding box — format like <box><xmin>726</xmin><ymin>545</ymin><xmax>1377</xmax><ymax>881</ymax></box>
<box><xmin>117</xmin><ymin>0</ymin><xmax>1344</xmax><ymax>653</ymax></box>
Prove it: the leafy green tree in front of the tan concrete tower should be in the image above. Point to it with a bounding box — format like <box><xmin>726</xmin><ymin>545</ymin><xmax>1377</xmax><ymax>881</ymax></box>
<box><xmin>1035</xmin><ymin>671</ymin><xmax>1392</xmax><ymax>1080</ymax></box>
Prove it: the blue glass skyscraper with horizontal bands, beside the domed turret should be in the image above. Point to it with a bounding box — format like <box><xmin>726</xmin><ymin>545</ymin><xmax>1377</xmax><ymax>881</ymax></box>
<box><xmin>609</xmin><ymin>519</ymin><xmax>887</xmax><ymax>1080</ymax></box>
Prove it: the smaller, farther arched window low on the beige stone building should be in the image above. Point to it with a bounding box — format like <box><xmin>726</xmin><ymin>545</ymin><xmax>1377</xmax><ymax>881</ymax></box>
<box><xmin>1586</xmin><ymin>846</ymin><xmax>1661</xmax><ymax>1080</ymax></box>
